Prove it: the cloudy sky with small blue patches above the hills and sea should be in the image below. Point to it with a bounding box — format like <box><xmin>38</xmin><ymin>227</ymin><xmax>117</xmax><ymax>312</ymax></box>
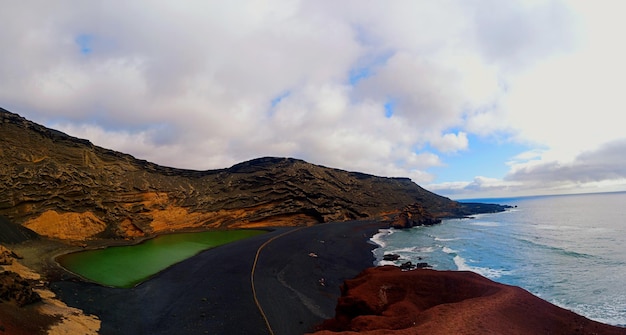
<box><xmin>0</xmin><ymin>0</ymin><xmax>626</xmax><ymax>199</ymax></box>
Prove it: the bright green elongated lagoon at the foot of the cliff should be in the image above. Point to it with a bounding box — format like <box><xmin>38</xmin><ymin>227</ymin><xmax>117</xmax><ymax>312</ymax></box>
<box><xmin>57</xmin><ymin>230</ymin><xmax>265</xmax><ymax>288</ymax></box>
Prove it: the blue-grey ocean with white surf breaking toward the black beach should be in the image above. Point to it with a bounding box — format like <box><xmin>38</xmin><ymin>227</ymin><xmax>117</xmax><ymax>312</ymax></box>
<box><xmin>372</xmin><ymin>192</ymin><xmax>626</xmax><ymax>326</ymax></box>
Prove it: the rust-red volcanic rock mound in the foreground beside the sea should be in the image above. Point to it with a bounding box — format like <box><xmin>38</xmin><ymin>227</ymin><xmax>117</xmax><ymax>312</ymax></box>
<box><xmin>315</xmin><ymin>266</ymin><xmax>626</xmax><ymax>335</ymax></box>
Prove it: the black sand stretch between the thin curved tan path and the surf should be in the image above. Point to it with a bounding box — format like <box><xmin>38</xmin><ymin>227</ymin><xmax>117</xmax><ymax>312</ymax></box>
<box><xmin>256</xmin><ymin>221</ymin><xmax>382</xmax><ymax>335</ymax></box>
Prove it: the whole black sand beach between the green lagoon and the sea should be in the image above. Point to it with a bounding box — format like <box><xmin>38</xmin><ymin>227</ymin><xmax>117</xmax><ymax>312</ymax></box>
<box><xmin>51</xmin><ymin>221</ymin><xmax>384</xmax><ymax>335</ymax></box>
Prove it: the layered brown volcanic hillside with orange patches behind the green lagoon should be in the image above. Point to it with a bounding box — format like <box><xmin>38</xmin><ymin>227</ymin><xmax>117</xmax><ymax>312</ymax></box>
<box><xmin>0</xmin><ymin>109</ymin><xmax>498</xmax><ymax>240</ymax></box>
